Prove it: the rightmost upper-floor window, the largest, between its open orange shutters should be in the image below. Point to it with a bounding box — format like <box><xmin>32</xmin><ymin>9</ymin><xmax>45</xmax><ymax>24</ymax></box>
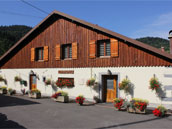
<box><xmin>97</xmin><ymin>40</ymin><xmax>111</xmax><ymax>57</ymax></box>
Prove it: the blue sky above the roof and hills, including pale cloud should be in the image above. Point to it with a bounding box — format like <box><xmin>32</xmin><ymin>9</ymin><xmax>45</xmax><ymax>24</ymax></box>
<box><xmin>0</xmin><ymin>0</ymin><xmax>172</xmax><ymax>39</ymax></box>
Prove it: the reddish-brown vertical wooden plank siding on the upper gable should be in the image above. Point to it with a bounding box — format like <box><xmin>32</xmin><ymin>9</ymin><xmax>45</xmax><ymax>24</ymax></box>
<box><xmin>1</xmin><ymin>18</ymin><xmax>172</xmax><ymax>69</ymax></box>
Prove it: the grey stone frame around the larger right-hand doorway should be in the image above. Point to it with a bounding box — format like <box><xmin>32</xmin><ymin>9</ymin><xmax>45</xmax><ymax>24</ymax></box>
<box><xmin>99</xmin><ymin>72</ymin><xmax>120</xmax><ymax>102</ymax></box>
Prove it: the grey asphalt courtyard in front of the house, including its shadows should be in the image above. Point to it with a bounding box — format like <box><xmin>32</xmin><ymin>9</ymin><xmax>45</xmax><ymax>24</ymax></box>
<box><xmin>0</xmin><ymin>95</ymin><xmax>172</xmax><ymax>129</ymax></box>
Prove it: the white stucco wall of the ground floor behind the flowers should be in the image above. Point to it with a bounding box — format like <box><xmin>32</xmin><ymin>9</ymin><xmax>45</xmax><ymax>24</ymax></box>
<box><xmin>0</xmin><ymin>67</ymin><xmax>172</xmax><ymax>107</ymax></box>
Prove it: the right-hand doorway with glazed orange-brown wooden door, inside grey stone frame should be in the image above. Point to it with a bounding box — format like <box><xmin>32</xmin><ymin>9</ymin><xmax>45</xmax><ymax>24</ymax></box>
<box><xmin>102</xmin><ymin>75</ymin><xmax>117</xmax><ymax>102</ymax></box>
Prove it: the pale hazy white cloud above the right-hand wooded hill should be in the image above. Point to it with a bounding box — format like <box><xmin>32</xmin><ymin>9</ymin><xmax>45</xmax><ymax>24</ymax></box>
<box><xmin>130</xmin><ymin>12</ymin><xmax>172</xmax><ymax>39</ymax></box>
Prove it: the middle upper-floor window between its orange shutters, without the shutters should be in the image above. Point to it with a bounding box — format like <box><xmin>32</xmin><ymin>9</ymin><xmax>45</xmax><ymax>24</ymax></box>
<box><xmin>62</xmin><ymin>44</ymin><xmax>72</xmax><ymax>59</ymax></box>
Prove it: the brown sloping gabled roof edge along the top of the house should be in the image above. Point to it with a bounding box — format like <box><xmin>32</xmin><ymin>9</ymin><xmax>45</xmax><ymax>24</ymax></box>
<box><xmin>0</xmin><ymin>10</ymin><xmax>172</xmax><ymax>61</ymax></box>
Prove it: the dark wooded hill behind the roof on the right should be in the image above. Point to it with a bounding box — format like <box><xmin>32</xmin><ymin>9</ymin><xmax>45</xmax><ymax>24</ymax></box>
<box><xmin>136</xmin><ymin>37</ymin><xmax>170</xmax><ymax>52</ymax></box>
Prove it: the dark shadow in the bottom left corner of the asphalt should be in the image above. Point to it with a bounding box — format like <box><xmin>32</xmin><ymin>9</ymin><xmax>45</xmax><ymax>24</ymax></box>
<box><xmin>0</xmin><ymin>113</ymin><xmax>26</xmax><ymax>129</ymax></box>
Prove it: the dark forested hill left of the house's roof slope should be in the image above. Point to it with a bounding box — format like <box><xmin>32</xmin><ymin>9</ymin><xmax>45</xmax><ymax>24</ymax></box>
<box><xmin>0</xmin><ymin>25</ymin><xmax>32</xmax><ymax>56</ymax></box>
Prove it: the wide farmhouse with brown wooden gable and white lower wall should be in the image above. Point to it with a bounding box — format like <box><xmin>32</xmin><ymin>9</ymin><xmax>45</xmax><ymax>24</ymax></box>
<box><xmin>0</xmin><ymin>11</ymin><xmax>172</xmax><ymax>104</ymax></box>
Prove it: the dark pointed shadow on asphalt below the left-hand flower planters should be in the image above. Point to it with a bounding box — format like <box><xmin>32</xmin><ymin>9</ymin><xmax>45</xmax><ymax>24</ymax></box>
<box><xmin>0</xmin><ymin>94</ymin><xmax>40</xmax><ymax>107</ymax></box>
